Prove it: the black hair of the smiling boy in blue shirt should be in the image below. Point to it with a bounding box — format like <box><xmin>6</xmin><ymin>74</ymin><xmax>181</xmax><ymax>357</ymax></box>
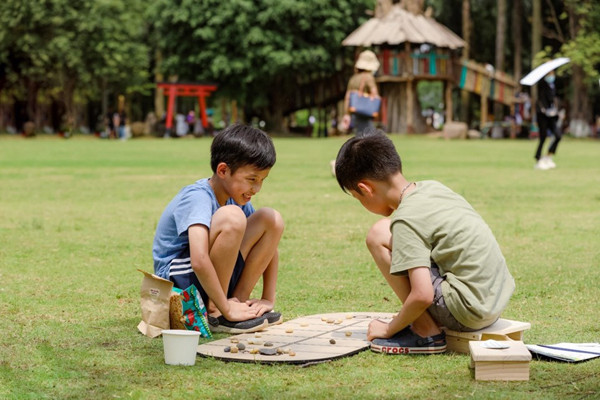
<box><xmin>210</xmin><ymin>124</ymin><xmax>276</xmax><ymax>174</ymax></box>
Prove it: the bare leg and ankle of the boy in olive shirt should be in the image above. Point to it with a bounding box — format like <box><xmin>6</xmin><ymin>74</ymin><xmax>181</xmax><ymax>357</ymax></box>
<box><xmin>367</xmin><ymin>218</ymin><xmax>440</xmax><ymax>337</ymax></box>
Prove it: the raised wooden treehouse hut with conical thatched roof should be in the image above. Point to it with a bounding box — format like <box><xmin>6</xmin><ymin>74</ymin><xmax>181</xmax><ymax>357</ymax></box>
<box><xmin>342</xmin><ymin>2</ymin><xmax>465</xmax><ymax>132</ymax></box>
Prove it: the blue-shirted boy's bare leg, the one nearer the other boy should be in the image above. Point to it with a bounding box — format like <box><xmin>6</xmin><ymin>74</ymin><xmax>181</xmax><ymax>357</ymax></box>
<box><xmin>234</xmin><ymin>208</ymin><xmax>284</xmax><ymax>302</ymax></box>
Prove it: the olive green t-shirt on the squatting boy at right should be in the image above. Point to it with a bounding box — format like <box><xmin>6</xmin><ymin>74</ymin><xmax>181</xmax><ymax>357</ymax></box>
<box><xmin>390</xmin><ymin>181</ymin><xmax>515</xmax><ymax>329</ymax></box>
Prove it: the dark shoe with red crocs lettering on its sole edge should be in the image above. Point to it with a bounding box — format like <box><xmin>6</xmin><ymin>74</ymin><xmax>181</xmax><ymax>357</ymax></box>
<box><xmin>371</xmin><ymin>327</ymin><xmax>447</xmax><ymax>354</ymax></box>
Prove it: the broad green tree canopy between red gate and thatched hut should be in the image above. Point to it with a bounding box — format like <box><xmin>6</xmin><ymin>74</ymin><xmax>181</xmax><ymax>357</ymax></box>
<box><xmin>149</xmin><ymin>0</ymin><xmax>374</xmax><ymax>127</ymax></box>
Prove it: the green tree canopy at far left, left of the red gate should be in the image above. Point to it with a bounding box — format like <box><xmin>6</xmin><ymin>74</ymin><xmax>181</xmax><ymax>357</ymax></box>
<box><xmin>0</xmin><ymin>0</ymin><xmax>148</xmax><ymax>126</ymax></box>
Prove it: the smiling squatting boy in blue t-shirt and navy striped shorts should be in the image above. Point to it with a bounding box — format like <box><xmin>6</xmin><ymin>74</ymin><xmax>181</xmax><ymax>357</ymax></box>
<box><xmin>152</xmin><ymin>125</ymin><xmax>284</xmax><ymax>333</ymax></box>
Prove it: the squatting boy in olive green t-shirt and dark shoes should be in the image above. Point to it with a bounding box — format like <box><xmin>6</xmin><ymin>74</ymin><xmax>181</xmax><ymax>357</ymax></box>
<box><xmin>335</xmin><ymin>131</ymin><xmax>515</xmax><ymax>354</ymax></box>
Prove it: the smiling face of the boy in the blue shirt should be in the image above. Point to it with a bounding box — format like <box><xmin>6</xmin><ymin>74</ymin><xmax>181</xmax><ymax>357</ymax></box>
<box><xmin>215</xmin><ymin>163</ymin><xmax>271</xmax><ymax>205</ymax></box>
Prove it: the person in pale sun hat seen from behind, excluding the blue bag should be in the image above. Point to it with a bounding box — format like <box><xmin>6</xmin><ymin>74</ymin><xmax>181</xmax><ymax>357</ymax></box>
<box><xmin>342</xmin><ymin>50</ymin><xmax>379</xmax><ymax>136</ymax></box>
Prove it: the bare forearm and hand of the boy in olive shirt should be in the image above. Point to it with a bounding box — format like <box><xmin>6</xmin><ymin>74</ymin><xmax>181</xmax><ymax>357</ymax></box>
<box><xmin>367</xmin><ymin>267</ymin><xmax>433</xmax><ymax>340</ymax></box>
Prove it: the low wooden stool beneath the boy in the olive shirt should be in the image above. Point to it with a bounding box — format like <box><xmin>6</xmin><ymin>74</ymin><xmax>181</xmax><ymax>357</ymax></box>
<box><xmin>444</xmin><ymin>318</ymin><xmax>531</xmax><ymax>354</ymax></box>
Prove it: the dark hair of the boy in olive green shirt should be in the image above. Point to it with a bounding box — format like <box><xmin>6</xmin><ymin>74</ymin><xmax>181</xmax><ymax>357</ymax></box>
<box><xmin>335</xmin><ymin>128</ymin><xmax>402</xmax><ymax>193</ymax></box>
